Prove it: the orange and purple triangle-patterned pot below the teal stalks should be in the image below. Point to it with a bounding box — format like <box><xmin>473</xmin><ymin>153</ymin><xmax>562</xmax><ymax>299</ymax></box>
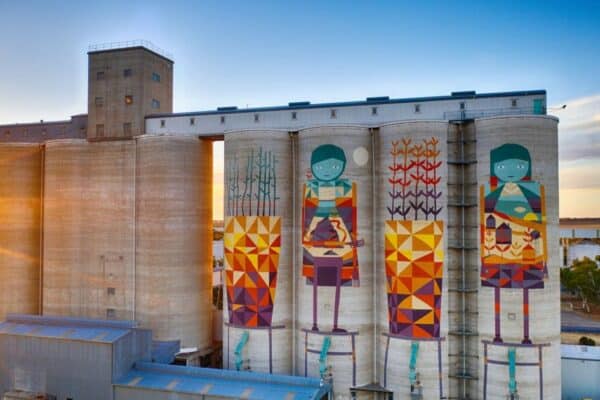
<box><xmin>223</xmin><ymin>216</ymin><xmax>281</xmax><ymax>328</ymax></box>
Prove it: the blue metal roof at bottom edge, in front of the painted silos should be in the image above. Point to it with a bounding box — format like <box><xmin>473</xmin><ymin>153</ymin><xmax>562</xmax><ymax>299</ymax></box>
<box><xmin>114</xmin><ymin>362</ymin><xmax>331</xmax><ymax>400</ymax></box>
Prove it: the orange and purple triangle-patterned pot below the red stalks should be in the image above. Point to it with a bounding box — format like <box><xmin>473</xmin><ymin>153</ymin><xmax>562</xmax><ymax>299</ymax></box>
<box><xmin>385</xmin><ymin>220</ymin><xmax>444</xmax><ymax>339</ymax></box>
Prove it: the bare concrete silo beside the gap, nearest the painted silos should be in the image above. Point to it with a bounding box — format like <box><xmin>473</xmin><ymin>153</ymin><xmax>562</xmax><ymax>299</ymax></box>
<box><xmin>135</xmin><ymin>136</ymin><xmax>212</xmax><ymax>349</ymax></box>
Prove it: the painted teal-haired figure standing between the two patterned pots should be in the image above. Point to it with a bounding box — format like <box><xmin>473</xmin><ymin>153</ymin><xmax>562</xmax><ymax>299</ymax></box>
<box><xmin>302</xmin><ymin>144</ymin><xmax>362</xmax><ymax>332</ymax></box>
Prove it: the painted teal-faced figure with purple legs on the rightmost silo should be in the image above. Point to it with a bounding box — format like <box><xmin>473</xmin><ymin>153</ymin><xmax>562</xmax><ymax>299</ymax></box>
<box><xmin>480</xmin><ymin>144</ymin><xmax>547</xmax><ymax>344</ymax></box>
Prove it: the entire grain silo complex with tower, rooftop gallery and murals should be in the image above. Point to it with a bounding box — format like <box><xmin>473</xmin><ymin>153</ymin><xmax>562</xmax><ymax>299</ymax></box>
<box><xmin>0</xmin><ymin>43</ymin><xmax>561</xmax><ymax>399</ymax></box>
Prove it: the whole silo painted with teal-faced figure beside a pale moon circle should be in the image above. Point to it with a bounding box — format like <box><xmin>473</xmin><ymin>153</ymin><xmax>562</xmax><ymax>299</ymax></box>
<box><xmin>294</xmin><ymin>126</ymin><xmax>375</xmax><ymax>394</ymax></box>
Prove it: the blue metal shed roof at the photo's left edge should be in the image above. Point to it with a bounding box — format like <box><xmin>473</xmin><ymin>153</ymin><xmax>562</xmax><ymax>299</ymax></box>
<box><xmin>0</xmin><ymin>315</ymin><xmax>131</xmax><ymax>343</ymax></box>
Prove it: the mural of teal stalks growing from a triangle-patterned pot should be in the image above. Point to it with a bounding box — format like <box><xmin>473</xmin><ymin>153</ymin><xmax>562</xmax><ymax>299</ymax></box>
<box><xmin>224</xmin><ymin>147</ymin><xmax>281</xmax><ymax>328</ymax></box>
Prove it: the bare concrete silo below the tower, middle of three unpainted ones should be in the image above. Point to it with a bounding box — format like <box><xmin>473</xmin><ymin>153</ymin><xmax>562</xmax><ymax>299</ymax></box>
<box><xmin>43</xmin><ymin>139</ymin><xmax>135</xmax><ymax>319</ymax></box>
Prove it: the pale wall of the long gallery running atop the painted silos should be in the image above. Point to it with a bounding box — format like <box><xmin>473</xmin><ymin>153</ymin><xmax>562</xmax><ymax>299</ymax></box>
<box><xmin>146</xmin><ymin>93</ymin><xmax>546</xmax><ymax>135</ymax></box>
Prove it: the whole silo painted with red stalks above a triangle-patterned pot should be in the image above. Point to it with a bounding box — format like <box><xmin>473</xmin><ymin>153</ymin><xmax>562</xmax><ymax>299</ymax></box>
<box><xmin>374</xmin><ymin>121</ymin><xmax>448</xmax><ymax>399</ymax></box>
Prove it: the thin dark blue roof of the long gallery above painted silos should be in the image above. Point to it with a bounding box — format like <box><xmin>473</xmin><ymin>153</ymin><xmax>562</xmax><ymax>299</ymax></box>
<box><xmin>145</xmin><ymin>89</ymin><xmax>546</xmax><ymax>119</ymax></box>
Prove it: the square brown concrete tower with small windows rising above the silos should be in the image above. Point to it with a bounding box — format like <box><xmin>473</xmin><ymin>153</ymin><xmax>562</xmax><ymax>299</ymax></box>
<box><xmin>87</xmin><ymin>42</ymin><xmax>173</xmax><ymax>140</ymax></box>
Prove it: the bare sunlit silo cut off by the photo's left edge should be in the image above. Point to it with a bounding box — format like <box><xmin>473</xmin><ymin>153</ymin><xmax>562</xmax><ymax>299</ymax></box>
<box><xmin>0</xmin><ymin>143</ymin><xmax>42</xmax><ymax>319</ymax></box>
